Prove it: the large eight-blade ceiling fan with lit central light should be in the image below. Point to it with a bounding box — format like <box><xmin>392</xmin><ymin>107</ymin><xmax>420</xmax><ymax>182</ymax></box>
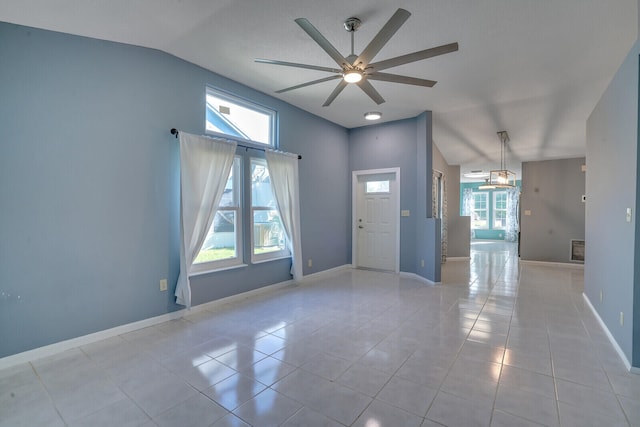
<box><xmin>255</xmin><ymin>9</ymin><xmax>458</xmax><ymax>107</ymax></box>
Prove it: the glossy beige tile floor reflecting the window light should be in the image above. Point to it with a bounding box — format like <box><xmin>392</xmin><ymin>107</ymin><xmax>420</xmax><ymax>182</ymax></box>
<box><xmin>0</xmin><ymin>242</ymin><xmax>640</xmax><ymax>427</ymax></box>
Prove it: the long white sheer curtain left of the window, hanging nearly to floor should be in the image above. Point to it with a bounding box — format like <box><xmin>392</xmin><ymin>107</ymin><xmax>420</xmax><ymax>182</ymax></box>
<box><xmin>175</xmin><ymin>132</ymin><xmax>237</xmax><ymax>308</ymax></box>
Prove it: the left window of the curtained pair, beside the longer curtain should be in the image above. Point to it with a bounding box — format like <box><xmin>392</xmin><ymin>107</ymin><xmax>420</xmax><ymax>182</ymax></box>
<box><xmin>193</xmin><ymin>157</ymin><xmax>242</xmax><ymax>272</ymax></box>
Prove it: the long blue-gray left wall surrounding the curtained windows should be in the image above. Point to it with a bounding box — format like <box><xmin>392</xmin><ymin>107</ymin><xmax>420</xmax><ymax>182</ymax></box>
<box><xmin>0</xmin><ymin>23</ymin><xmax>351</xmax><ymax>357</ymax></box>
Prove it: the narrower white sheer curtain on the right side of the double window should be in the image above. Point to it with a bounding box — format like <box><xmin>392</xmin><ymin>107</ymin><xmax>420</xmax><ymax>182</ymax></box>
<box><xmin>265</xmin><ymin>150</ymin><xmax>302</xmax><ymax>281</ymax></box>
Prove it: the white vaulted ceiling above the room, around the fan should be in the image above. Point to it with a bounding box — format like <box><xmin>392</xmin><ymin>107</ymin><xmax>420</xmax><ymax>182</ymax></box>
<box><xmin>0</xmin><ymin>0</ymin><xmax>638</xmax><ymax>176</ymax></box>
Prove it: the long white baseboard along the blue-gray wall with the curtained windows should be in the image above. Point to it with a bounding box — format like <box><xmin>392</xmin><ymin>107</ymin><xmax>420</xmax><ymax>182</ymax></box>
<box><xmin>0</xmin><ymin>264</ymin><xmax>351</xmax><ymax>369</ymax></box>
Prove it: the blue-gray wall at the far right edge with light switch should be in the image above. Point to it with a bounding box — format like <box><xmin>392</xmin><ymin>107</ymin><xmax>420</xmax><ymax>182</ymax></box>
<box><xmin>584</xmin><ymin>42</ymin><xmax>640</xmax><ymax>367</ymax></box>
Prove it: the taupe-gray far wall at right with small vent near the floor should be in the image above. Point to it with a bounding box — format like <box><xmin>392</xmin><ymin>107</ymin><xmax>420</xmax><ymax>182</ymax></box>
<box><xmin>520</xmin><ymin>157</ymin><xmax>585</xmax><ymax>263</ymax></box>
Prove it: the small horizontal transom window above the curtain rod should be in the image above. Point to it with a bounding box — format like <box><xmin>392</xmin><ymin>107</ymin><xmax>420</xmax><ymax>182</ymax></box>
<box><xmin>206</xmin><ymin>88</ymin><xmax>276</xmax><ymax>147</ymax></box>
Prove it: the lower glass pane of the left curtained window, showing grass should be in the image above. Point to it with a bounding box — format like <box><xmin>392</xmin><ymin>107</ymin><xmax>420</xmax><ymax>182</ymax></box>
<box><xmin>193</xmin><ymin>210</ymin><xmax>238</xmax><ymax>264</ymax></box>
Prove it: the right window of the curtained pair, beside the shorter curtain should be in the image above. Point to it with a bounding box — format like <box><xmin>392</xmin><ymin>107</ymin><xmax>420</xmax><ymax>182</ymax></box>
<box><xmin>251</xmin><ymin>158</ymin><xmax>290</xmax><ymax>262</ymax></box>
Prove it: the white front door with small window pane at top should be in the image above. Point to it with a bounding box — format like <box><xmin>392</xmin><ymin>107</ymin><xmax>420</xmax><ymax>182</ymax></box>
<box><xmin>354</xmin><ymin>171</ymin><xmax>399</xmax><ymax>272</ymax></box>
